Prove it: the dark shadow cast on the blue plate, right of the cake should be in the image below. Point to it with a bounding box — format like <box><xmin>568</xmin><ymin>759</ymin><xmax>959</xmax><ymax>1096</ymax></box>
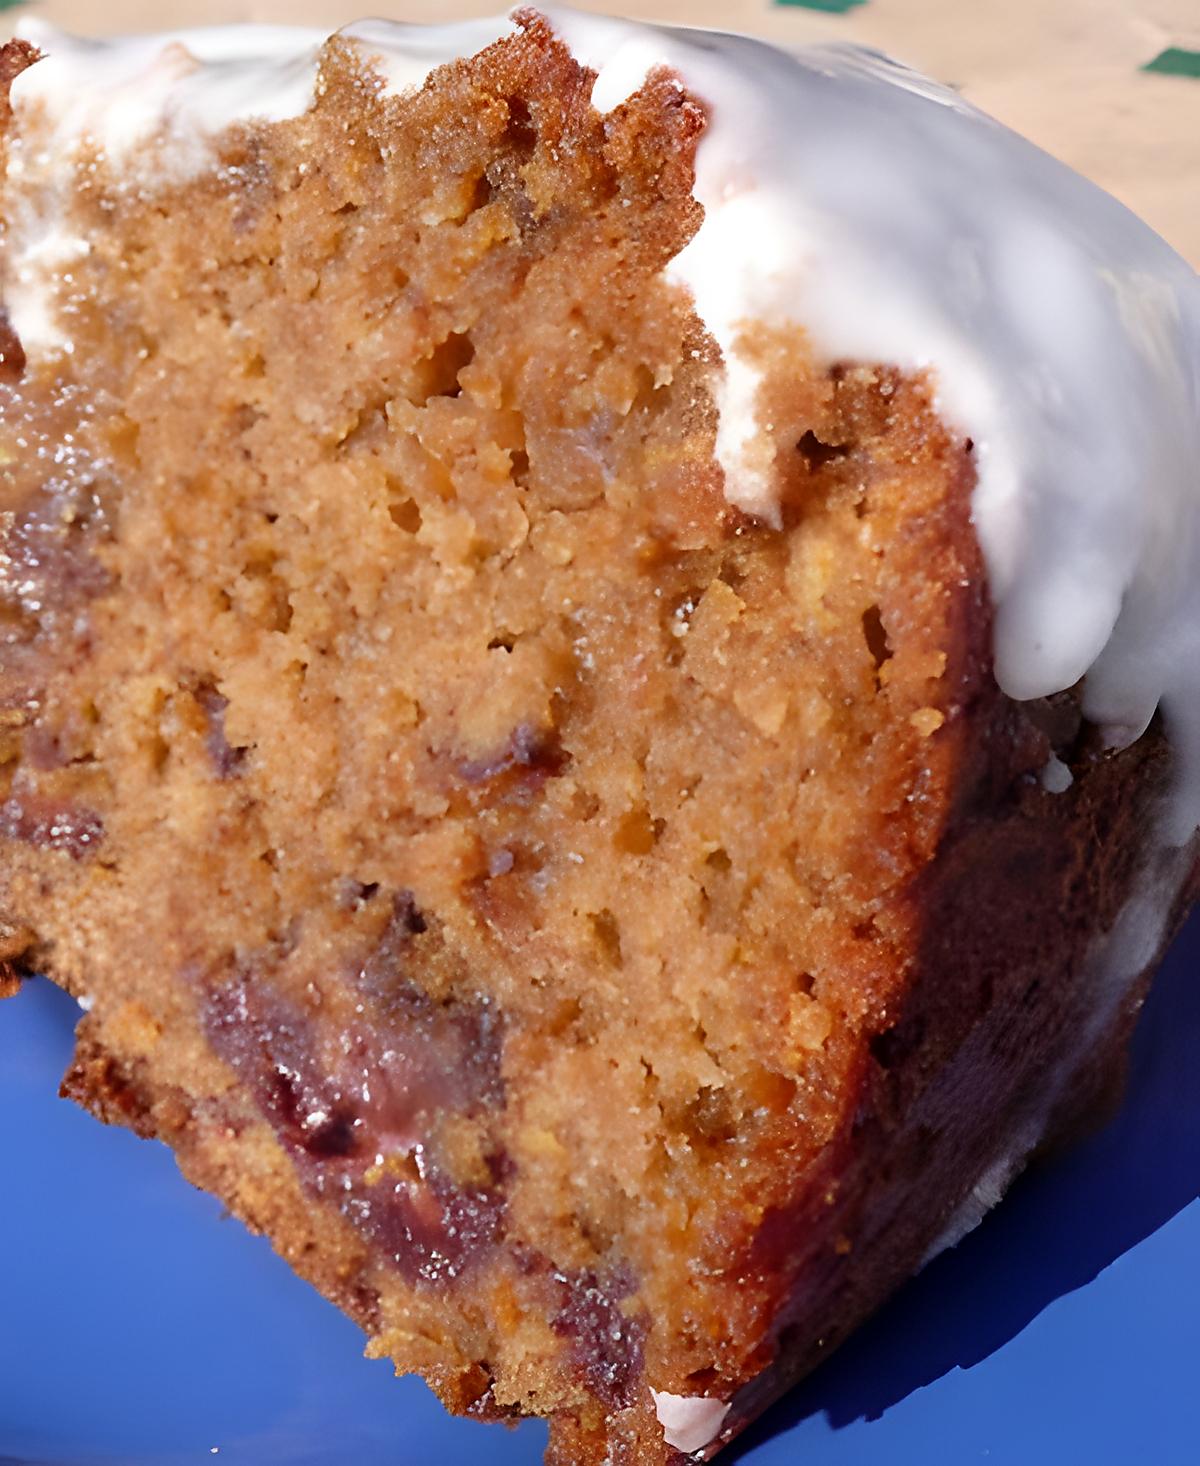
<box><xmin>732</xmin><ymin>910</ymin><xmax>1200</xmax><ymax>1466</ymax></box>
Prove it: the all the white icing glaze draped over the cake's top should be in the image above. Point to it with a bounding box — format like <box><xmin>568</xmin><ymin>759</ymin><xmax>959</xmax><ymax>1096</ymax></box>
<box><xmin>7</xmin><ymin>9</ymin><xmax>1200</xmax><ymax>844</ymax></box>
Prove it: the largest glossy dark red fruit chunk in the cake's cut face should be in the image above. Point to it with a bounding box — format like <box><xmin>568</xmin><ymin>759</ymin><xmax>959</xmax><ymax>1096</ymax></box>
<box><xmin>205</xmin><ymin>926</ymin><xmax>504</xmax><ymax>1283</ymax></box>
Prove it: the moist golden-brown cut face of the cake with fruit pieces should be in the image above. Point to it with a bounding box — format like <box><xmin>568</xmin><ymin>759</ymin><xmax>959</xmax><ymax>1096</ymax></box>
<box><xmin>0</xmin><ymin>19</ymin><xmax>1107</xmax><ymax>1462</ymax></box>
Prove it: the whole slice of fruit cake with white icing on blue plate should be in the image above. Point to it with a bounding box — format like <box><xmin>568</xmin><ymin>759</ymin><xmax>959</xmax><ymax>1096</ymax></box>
<box><xmin>0</xmin><ymin>10</ymin><xmax>1200</xmax><ymax>1466</ymax></box>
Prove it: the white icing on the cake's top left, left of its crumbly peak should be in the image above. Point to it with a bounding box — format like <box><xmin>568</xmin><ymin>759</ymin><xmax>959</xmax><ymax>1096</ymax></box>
<box><xmin>6</xmin><ymin>15</ymin><xmax>514</xmax><ymax>356</ymax></box>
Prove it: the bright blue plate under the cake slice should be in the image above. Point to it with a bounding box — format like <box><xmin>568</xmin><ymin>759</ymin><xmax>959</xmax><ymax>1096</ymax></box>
<box><xmin>0</xmin><ymin>918</ymin><xmax>1200</xmax><ymax>1466</ymax></box>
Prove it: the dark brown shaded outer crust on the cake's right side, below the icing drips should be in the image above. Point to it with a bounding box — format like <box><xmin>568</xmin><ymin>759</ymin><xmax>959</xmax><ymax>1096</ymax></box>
<box><xmin>709</xmin><ymin>721</ymin><xmax>1200</xmax><ymax>1441</ymax></box>
